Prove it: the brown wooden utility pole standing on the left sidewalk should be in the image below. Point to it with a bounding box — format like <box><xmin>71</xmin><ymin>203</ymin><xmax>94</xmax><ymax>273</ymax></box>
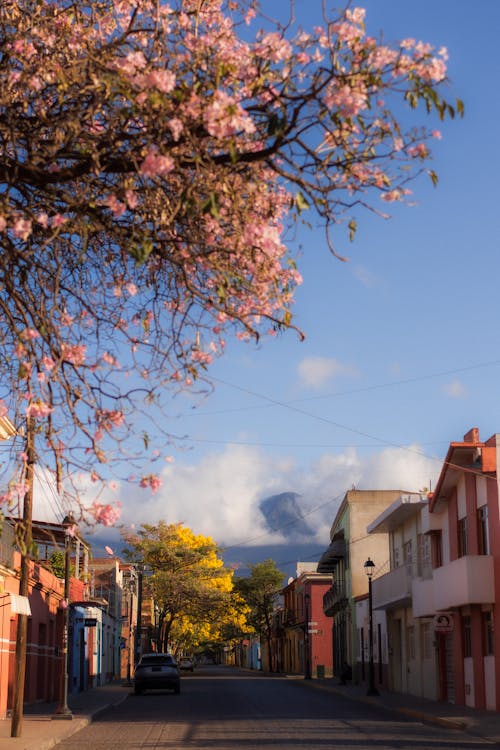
<box><xmin>10</xmin><ymin>417</ymin><xmax>35</xmax><ymax>737</ymax></box>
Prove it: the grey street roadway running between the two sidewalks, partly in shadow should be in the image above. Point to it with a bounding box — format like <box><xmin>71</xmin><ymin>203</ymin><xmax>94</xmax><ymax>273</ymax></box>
<box><xmin>53</xmin><ymin>667</ymin><xmax>491</xmax><ymax>750</ymax></box>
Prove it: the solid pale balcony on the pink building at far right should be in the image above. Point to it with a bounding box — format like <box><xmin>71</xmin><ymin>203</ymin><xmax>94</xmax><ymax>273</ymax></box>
<box><xmin>412</xmin><ymin>555</ymin><xmax>495</xmax><ymax>617</ymax></box>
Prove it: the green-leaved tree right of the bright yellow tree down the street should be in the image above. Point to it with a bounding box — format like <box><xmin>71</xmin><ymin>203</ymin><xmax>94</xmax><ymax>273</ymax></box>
<box><xmin>234</xmin><ymin>559</ymin><xmax>285</xmax><ymax>664</ymax></box>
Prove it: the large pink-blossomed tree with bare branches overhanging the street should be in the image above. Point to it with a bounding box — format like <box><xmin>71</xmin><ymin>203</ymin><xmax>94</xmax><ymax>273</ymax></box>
<box><xmin>0</xmin><ymin>0</ymin><xmax>461</xmax><ymax>523</ymax></box>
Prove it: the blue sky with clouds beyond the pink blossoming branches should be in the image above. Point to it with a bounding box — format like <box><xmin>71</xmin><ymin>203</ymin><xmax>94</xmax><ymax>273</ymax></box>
<box><xmin>34</xmin><ymin>0</ymin><xmax>500</xmax><ymax>560</ymax></box>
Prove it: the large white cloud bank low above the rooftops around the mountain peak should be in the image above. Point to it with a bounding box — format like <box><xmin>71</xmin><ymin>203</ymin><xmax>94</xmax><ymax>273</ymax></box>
<box><xmin>49</xmin><ymin>445</ymin><xmax>440</xmax><ymax>550</ymax></box>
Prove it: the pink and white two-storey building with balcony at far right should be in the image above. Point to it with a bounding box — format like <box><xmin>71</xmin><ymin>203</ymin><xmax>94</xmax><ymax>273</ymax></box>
<box><xmin>413</xmin><ymin>428</ymin><xmax>500</xmax><ymax>711</ymax></box>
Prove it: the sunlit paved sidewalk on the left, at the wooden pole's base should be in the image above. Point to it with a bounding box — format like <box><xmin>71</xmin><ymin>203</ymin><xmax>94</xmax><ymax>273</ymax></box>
<box><xmin>0</xmin><ymin>680</ymin><xmax>131</xmax><ymax>750</ymax></box>
